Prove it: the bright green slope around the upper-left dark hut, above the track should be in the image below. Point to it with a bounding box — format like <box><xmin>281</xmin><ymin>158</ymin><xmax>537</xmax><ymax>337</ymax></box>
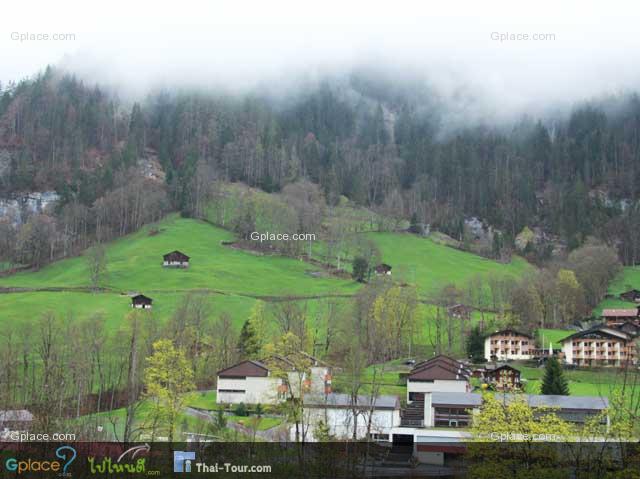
<box><xmin>0</xmin><ymin>215</ymin><xmax>356</xmax><ymax>296</ymax></box>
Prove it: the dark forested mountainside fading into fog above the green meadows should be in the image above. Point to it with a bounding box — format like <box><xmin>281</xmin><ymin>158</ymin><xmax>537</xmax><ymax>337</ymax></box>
<box><xmin>0</xmin><ymin>68</ymin><xmax>640</xmax><ymax>266</ymax></box>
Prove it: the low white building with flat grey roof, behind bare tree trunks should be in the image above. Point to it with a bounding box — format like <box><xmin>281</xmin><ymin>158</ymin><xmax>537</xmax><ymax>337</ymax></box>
<box><xmin>300</xmin><ymin>393</ymin><xmax>400</xmax><ymax>441</ymax></box>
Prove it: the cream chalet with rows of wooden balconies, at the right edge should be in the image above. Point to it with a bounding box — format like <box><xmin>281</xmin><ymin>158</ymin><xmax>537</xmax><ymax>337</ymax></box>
<box><xmin>560</xmin><ymin>326</ymin><xmax>636</xmax><ymax>366</ymax></box>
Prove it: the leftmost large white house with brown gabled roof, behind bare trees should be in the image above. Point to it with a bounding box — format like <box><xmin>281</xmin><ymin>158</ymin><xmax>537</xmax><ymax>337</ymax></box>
<box><xmin>216</xmin><ymin>352</ymin><xmax>331</xmax><ymax>404</ymax></box>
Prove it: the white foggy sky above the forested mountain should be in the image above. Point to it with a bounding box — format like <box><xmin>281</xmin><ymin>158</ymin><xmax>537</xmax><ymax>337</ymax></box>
<box><xmin>0</xmin><ymin>0</ymin><xmax>640</xmax><ymax>122</ymax></box>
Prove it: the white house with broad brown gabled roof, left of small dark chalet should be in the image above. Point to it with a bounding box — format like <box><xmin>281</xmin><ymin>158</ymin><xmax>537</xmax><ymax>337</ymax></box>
<box><xmin>407</xmin><ymin>354</ymin><xmax>471</xmax><ymax>402</ymax></box>
